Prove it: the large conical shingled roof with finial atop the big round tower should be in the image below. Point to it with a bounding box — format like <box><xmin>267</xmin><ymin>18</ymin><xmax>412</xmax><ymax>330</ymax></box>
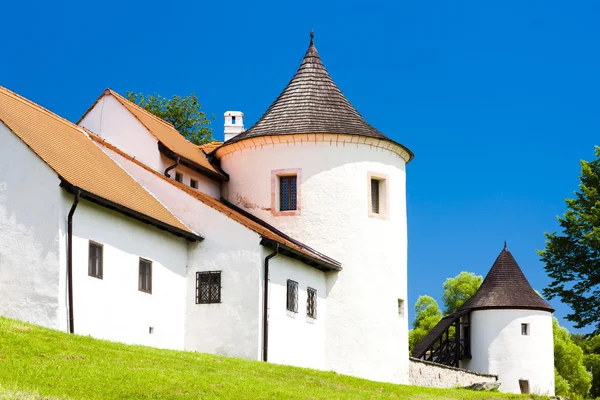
<box><xmin>224</xmin><ymin>32</ymin><xmax>413</xmax><ymax>159</ymax></box>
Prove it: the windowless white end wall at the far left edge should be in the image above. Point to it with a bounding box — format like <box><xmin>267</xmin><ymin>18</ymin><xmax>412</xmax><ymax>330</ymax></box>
<box><xmin>0</xmin><ymin>122</ymin><xmax>66</xmax><ymax>329</ymax></box>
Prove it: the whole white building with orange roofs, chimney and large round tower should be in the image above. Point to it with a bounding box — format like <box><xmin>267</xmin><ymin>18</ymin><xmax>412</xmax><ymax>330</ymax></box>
<box><xmin>0</xmin><ymin>32</ymin><xmax>412</xmax><ymax>383</ymax></box>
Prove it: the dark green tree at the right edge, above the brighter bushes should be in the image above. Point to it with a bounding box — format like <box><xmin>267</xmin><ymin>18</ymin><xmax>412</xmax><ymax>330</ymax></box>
<box><xmin>538</xmin><ymin>146</ymin><xmax>600</xmax><ymax>334</ymax></box>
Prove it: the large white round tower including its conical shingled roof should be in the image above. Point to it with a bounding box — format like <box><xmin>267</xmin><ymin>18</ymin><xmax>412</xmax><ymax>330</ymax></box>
<box><xmin>215</xmin><ymin>33</ymin><xmax>413</xmax><ymax>383</ymax></box>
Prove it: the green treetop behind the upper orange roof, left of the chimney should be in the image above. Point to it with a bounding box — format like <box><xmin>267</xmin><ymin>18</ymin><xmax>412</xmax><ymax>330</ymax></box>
<box><xmin>126</xmin><ymin>92</ymin><xmax>215</xmax><ymax>145</ymax></box>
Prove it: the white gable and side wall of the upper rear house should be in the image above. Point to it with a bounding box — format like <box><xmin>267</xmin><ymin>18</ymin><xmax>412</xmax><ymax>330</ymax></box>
<box><xmin>79</xmin><ymin>95</ymin><xmax>220</xmax><ymax>198</ymax></box>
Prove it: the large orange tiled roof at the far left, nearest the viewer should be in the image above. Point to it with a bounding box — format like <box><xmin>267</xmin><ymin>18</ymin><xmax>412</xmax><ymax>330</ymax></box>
<box><xmin>0</xmin><ymin>87</ymin><xmax>200</xmax><ymax>238</ymax></box>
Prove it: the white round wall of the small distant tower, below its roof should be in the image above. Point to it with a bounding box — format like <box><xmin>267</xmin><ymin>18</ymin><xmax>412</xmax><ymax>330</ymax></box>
<box><xmin>461</xmin><ymin>310</ymin><xmax>554</xmax><ymax>395</ymax></box>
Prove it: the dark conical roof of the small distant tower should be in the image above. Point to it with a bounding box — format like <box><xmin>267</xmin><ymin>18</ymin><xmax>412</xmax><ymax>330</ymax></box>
<box><xmin>459</xmin><ymin>245</ymin><xmax>554</xmax><ymax>312</ymax></box>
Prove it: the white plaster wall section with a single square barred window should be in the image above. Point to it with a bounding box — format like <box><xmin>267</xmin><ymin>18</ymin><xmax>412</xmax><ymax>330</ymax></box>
<box><xmin>101</xmin><ymin>147</ymin><xmax>263</xmax><ymax>360</ymax></box>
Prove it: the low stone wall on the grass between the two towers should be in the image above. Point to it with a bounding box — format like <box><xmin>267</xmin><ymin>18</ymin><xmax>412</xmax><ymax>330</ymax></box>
<box><xmin>408</xmin><ymin>357</ymin><xmax>498</xmax><ymax>388</ymax></box>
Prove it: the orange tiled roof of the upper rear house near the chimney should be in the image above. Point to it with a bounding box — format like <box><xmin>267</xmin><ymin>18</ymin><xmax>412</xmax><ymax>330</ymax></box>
<box><xmin>79</xmin><ymin>89</ymin><xmax>227</xmax><ymax>180</ymax></box>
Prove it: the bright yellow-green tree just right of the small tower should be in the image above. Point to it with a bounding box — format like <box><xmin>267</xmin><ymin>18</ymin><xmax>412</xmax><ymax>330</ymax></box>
<box><xmin>552</xmin><ymin>318</ymin><xmax>592</xmax><ymax>400</ymax></box>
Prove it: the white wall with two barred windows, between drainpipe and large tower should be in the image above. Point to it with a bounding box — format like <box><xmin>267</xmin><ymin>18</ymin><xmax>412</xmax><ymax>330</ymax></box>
<box><xmin>263</xmin><ymin>249</ymin><xmax>327</xmax><ymax>369</ymax></box>
